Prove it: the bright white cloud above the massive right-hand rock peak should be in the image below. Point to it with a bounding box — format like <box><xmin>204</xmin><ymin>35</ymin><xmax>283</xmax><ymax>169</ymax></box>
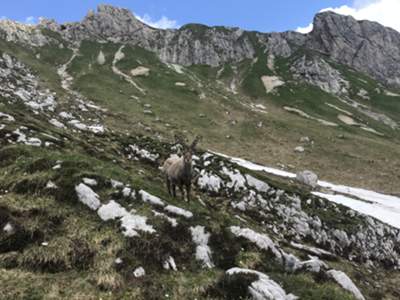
<box><xmin>296</xmin><ymin>0</ymin><xmax>400</xmax><ymax>33</ymax></box>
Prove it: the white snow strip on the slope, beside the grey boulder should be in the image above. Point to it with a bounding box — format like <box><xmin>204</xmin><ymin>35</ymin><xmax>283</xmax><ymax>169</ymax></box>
<box><xmin>214</xmin><ymin>151</ymin><xmax>400</xmax><ymax>229</ymax></box>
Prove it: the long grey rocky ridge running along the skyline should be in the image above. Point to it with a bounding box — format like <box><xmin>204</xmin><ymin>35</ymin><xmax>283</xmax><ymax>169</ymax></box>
<box><xmin>0</xmin><ymin>5</ymin><xmax>400</xmax><ymax>88</ymax></box>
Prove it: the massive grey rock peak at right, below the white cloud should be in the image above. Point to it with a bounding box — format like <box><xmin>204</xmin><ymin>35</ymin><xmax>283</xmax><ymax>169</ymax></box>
<box><xmin>306</xmin><ymin>12</ymin><xmax>400</xmax><ymax>86</ymax></box>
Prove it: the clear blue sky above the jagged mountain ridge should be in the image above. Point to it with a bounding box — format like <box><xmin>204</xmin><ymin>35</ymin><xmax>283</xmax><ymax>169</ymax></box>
<box><xmin>0</xmin><ymin>0</ymin><xmax>353</xmax><ymax>32</ymax></box>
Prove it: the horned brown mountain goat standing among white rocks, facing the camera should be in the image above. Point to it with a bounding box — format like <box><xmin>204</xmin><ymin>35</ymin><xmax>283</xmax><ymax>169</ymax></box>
<box><xmin>161</xmin><ymin>136</ymin><xmax>200</xmax><ymax>201</ymax></box>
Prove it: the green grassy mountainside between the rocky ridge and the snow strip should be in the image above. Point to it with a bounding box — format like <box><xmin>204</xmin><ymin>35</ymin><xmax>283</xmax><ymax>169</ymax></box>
<box><xmin>64</xmin><ymin>39</ymin><xmax>399</xmax><ymax>193</ymax></box>
